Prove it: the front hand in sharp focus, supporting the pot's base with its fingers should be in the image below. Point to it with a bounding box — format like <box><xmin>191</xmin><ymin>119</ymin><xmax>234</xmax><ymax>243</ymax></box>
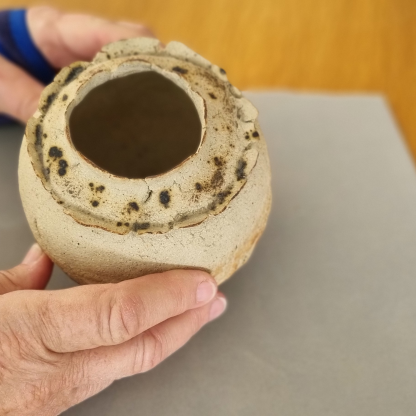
<box><xmin>0</xmin><ymin>245</ymin><xmax>226</xmax><ymax>416</ymax></box>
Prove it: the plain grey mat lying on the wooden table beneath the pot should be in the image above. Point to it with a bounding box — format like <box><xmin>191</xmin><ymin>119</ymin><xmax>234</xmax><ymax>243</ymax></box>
<box><xmin>0</xmin><ymin>93</ymin><xmax>416</xmax><ymax>416</ymax></box>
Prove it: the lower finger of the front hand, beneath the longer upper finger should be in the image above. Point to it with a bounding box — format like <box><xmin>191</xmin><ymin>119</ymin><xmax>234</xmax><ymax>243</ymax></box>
<box><xmin>68</xmin><ymin>293</ymin><xmax>226</xmax><ymax>383</ymax></box>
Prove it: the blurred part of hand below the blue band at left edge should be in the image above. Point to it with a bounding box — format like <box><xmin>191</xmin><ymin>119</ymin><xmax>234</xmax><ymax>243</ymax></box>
<box><xmin>0</xmin><ymin>56</ymin><xmax>43</xmax><ymax>123</ymax></box>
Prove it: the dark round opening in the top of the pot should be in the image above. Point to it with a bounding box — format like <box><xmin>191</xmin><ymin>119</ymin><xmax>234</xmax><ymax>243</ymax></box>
<box><xmin>69</xmin><ymin>71</ymin><xmax>202</xmax><ymax>178</ymax></box>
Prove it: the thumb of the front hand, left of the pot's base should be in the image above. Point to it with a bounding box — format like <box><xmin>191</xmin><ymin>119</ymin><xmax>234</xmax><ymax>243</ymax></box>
<box><xmin>0</xmin><ymin>244</ymin><xmax>53</xmax><ymax>295</ymax></box>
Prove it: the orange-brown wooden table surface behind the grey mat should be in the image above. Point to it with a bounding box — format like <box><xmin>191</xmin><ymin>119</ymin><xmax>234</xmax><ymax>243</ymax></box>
<box><xmin>0</xmin><ymin>0</ymin><xmax>416</xmax><ymax>156</ymax></box>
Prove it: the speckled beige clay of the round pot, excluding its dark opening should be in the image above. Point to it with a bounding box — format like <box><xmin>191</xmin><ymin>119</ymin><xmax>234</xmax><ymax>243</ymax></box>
<box><xmin>19</xmin><ymin>38</ymin><xmax>271</xmax><ymax>283</ymax></box>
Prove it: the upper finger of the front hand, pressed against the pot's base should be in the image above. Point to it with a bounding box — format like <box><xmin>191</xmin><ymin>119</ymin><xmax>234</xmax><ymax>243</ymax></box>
<box><xmin>23</xmin><ymin>270</ymin><xmax>217</xmax><ymax>353</ymax></box>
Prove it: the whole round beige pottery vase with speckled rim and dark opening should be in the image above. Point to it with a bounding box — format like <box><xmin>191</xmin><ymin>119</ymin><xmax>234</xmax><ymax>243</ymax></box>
<box><xmin>19</xmin><ymin>38</ymin><xmax>271</xmax><ymax>284</ymax></box>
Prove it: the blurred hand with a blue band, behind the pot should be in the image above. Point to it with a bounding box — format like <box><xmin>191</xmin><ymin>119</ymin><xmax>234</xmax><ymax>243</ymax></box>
<box><xmin>0</xmin><ymin>7</ymin><xmax>154</xmax><ymax>123</ymax></box>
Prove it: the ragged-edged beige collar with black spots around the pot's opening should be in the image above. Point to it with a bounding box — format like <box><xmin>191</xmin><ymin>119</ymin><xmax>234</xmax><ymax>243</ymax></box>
<box><xmin>25</xmin><ymin>38</ymin><xmax>264</xmax><ymax>235</ymax></box>
